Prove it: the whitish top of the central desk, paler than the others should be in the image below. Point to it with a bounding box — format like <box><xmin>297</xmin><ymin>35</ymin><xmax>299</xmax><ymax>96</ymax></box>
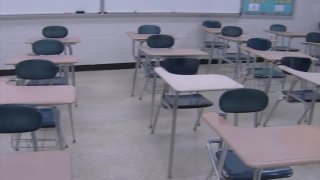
<box><xmin>155</xmin><ymin>67</ymin><xmax>243</xmax><ymax>92</ymax></box>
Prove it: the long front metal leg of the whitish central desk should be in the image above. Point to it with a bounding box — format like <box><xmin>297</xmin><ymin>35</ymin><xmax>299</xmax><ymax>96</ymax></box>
<box><xmin>168</xmin><ymin>92</ymin><xmax>179</xmax><ymax>178</ymax></box>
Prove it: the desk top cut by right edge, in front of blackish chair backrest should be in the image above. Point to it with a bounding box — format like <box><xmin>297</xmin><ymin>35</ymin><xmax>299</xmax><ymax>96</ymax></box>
<box><xmin>278</xmin><ymin>65</ymin><xmax>320</xmax><ymax>85</ymax></box>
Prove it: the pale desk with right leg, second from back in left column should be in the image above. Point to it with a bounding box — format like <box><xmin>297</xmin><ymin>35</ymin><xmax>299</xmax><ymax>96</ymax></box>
<box><xmin>5</xmin><ymin>54</ymin><xmax>79</xmax><ymax>86</ymax></box>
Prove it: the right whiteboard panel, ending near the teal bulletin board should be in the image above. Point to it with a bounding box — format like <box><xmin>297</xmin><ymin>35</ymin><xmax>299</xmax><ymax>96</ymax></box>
<box><xmin>104</xmin><ymin>0</ymin><xmax>241</xmax><ymax>13</ymax></box>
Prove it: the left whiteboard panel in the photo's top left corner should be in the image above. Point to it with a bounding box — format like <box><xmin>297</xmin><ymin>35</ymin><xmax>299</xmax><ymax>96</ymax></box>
<box><xmin>0</xmin><ymin>0</ymin><xmax>100</xmax><ymax>15</ymax></box>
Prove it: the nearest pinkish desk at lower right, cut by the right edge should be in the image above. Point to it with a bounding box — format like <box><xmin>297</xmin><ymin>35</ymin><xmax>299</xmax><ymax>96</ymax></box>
<box><xmin>203</xmin><ymin>112</ymin><xmax>320</xmax><ymax>180</ymax></box>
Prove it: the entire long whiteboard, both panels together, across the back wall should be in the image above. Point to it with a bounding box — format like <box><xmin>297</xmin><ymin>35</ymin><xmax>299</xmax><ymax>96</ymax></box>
<box><xmin>0</xmin><ymin>0</ymin><xmax>241</xmax><ymax>15</ymax></box>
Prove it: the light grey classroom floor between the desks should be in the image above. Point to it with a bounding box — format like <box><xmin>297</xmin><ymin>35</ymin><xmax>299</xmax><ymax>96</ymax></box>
<box><xmin>0</xmin><ymin>65</ymin><xmax>320</xmax><ymax>180</ymax></box>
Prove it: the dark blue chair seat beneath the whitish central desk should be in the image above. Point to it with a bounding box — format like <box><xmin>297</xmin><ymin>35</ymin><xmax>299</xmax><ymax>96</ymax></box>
<box><xmin>163</xmin><ymin>94</ymin><xmax>213</xmax><ymax>109</ymax></box>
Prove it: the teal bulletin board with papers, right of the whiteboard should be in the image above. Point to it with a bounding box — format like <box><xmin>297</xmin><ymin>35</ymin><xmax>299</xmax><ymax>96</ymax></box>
<box><xmin>241</xmin><ymin>0</ymin><xmax>295</xmax><ymax>16</ymax></box>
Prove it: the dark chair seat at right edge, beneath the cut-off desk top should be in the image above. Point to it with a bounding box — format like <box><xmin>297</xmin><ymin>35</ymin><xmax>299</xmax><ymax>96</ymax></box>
<box><xmin>282</xmin><ymin>90</ymin><xmax>320</xmax><ymax>102</ymax></box>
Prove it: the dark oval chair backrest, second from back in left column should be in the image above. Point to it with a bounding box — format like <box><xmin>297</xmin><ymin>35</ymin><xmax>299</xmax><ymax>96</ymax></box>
<box><xmin>32</xmin><ymin>39</ymin><xmax>64</xmax><ymax>55</ymax></box>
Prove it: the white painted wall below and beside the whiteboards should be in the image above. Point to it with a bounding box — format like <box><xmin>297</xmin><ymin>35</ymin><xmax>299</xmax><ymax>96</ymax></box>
<box><xmin>0</xmin><ymin>0</ymin><xmax>320</xmax><ymax>69</ymax></box>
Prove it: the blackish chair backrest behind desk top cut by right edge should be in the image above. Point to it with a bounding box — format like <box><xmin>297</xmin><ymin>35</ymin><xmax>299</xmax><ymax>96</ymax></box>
<box><xmin>280</xmin><ymin>57</ymin><xmax>311</xmax><ymax>74</ymax></box>
